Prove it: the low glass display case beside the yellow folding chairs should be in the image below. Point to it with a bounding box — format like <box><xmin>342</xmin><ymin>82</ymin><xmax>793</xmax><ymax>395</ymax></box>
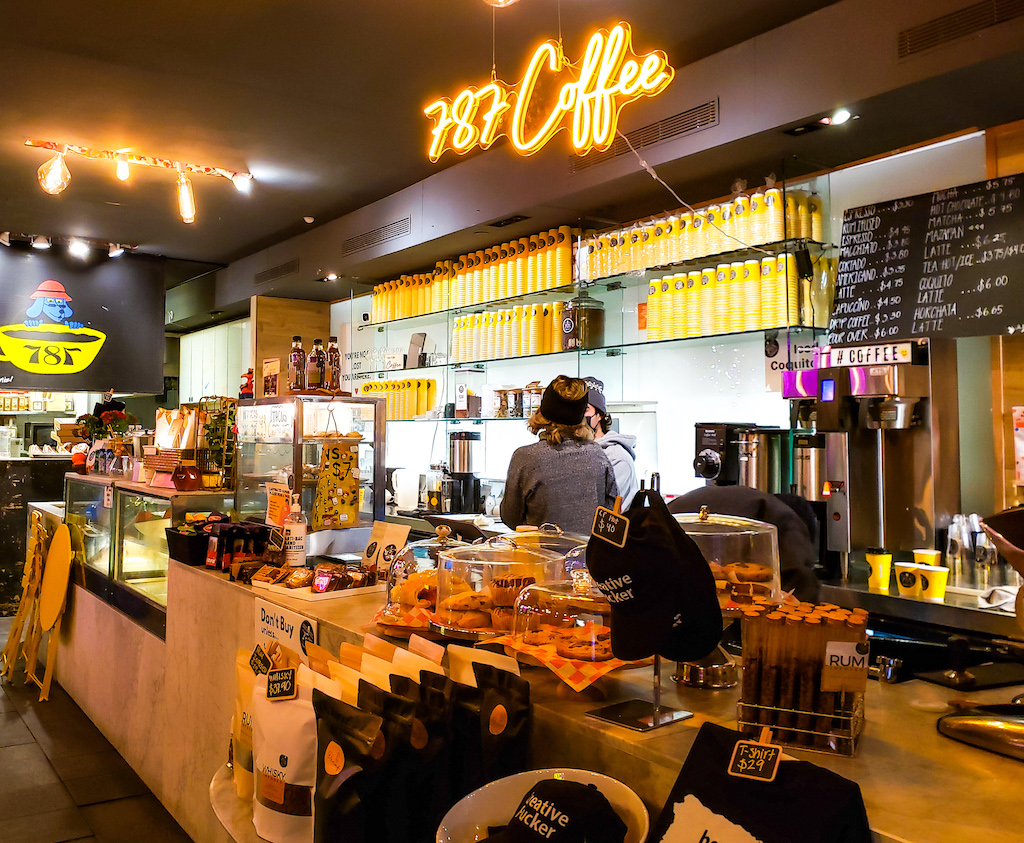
<box><xmin>65</xmin><ymin>473</ymin><xmax>234</xmax><ymax>637</ymax></box>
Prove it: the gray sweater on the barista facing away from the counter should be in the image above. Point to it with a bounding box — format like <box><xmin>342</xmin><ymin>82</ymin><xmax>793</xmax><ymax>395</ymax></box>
<box><xmin>501</xmin><ymin>439</ymin><xmax>617</xmax><ymax>536</ymax></box>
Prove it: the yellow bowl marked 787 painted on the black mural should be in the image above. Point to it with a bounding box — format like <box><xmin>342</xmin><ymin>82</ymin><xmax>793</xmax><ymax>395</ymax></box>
<box><xmin>0</xmin><ymin>325</ymin><xmax>106</xmax><ymax>375</ymax></box>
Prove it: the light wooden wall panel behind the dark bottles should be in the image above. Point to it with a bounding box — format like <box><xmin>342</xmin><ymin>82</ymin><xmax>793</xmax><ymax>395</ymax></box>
<box><xmin>249</xmin><ymin>296</ymin><xmax>331</xmax><ymax>398</ymax></box>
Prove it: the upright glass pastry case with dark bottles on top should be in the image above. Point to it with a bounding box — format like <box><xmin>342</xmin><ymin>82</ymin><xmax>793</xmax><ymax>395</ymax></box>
<box><xmin>237</xmin><ymin>394</ymin><xmax>384</xmax><ymax>555</ymax></box>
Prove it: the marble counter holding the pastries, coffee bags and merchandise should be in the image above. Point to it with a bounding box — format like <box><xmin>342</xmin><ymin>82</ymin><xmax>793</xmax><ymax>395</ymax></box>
<box><xmin>58</xmin><ymin>562</ymin><xmax>1024</xmax><ymax>843</ymax></box>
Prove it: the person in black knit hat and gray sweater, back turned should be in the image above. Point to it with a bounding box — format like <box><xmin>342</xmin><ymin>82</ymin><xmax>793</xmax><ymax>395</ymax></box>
<box><xmin>501</xmin><ymin>375</ymin><xmax>618</xmax><ymax>535</ymax></box>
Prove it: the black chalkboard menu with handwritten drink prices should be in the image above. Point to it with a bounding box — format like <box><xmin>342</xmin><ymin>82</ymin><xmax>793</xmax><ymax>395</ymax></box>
<box><xmin>828</xmin><ymin>175</ymin><xmax>1024</xmax><ymax>344</ymax></box>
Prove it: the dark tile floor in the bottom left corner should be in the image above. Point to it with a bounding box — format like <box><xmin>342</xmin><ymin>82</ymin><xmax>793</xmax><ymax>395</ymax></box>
<box><xmin>0</xmin><ymin>618</ymin><xmax>190</xmax><ymax>843</ymax></box>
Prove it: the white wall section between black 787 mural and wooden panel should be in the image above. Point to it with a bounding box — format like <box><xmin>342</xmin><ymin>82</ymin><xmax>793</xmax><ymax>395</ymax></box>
<box><xmin>178</xmin><ymin>319</ymin><xmax>253</xmax><ymax>404</ymax></box>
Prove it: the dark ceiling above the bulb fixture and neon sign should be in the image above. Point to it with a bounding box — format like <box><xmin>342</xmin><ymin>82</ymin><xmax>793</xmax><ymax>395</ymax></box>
<box><xmin>0</xmin><ymin>0</ymin><xmax>843</xmax><ymax>272</ymax></box>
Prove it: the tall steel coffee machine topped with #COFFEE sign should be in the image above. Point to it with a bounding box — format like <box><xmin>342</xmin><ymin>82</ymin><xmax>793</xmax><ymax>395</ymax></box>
<box><xmin>783</xmin><ymin>339</ymin><xmax>959</xmax><ymax>565</ymax></box>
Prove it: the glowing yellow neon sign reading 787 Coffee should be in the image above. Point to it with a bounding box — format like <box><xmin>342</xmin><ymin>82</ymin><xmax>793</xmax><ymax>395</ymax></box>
<box><xmin>423</xmin><ymin>23</ymin><xmax>675</xmax><ymax>161</ymax></box>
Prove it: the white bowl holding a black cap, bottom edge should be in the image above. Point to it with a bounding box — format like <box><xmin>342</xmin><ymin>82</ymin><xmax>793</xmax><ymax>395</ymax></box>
<box><xmin>436</xmin><ymin>768</ymin><xmax>650</xmax><ymax>843</ymax></box>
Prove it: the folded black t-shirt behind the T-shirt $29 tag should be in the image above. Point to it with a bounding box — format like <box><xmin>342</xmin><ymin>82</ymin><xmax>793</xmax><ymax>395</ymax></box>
<box><xmin>647</xmin><ymin>723</ymin><xmax>871</xmax><ymax>843</ymax></box>
